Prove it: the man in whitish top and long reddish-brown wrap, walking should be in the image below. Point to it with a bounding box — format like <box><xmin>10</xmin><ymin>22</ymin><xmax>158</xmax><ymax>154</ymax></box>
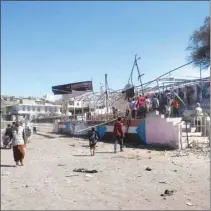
<box><xmin>12</xmin><ymin>122</ymin><xmax>26</xmax><ymax>166</ymax></box>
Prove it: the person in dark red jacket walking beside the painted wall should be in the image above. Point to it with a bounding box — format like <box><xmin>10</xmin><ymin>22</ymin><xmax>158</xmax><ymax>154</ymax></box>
<box><xmin>114</xmin><ymin>117</ymin><xmax>124</xmax><ymax>153</ymax></box>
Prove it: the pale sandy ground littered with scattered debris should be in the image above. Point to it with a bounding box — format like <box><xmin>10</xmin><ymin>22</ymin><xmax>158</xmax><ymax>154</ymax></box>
<box><xmin>1</xmin><ymin>135</ymin><xmax>210</xmax><ymax>210</ymax></box>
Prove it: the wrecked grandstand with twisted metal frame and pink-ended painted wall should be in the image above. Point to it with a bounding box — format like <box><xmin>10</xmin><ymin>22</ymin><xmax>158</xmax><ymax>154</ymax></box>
<box><xmin>52</xmin><ymin>56</ymin><xmax>210</xmax><ymax>149</ymax></box>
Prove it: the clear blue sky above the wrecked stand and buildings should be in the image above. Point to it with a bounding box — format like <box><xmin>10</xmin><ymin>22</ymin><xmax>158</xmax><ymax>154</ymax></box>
<box><xmin>1</xmin><ymin>1</ymin><xmax>210</xmax><ymax>99</ymax></box>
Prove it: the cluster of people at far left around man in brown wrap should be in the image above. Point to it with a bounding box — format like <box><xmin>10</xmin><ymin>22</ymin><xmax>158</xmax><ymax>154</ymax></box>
<box><xmin>3</xmin><ymin>121</ymin><xmax>31</xmax><ymax>167</ymax></box>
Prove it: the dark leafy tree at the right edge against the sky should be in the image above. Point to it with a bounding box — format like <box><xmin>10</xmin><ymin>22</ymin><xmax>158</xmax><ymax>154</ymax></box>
<box><xmin>187</xmin><ymin>17</ymin><xmax>210</xmax><ymax>69</ymax></box>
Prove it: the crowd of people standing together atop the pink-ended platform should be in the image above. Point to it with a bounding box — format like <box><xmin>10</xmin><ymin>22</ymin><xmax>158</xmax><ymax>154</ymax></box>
<box><xmin>126</xmin><ymin>91</ymin><xmax>183</xmax><ymax>119</ymax></box>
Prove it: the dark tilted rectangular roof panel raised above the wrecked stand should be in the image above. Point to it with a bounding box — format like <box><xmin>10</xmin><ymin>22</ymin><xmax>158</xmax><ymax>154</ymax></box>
<box><xmin>52</xmin><ymin>81</ymin><xmax>93</xmax><ymax>95</ymax></box>
